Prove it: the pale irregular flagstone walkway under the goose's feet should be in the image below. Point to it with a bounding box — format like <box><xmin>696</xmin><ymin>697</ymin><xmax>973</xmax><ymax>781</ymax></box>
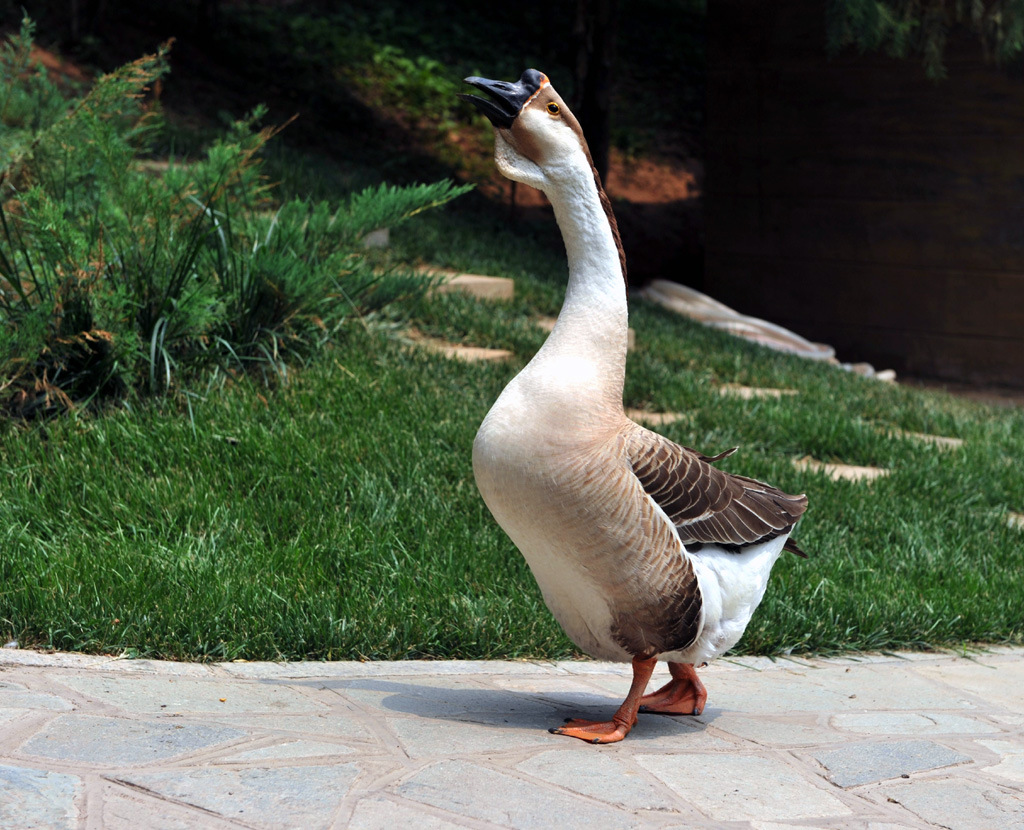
<box><xmin>0</xmin><ymin>649</ymin><xmax>1024</xmax><ymax>830</ymax></box>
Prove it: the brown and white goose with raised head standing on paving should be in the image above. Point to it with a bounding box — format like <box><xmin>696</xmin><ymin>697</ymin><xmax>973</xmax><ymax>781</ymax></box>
<box><xmin>460</xmin><ymin>70</ymin><xmax>807</xmax><ymax>744</ymax></box>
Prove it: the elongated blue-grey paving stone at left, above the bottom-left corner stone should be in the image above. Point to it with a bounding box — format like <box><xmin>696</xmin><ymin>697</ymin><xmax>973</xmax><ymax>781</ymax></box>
<box><xmin>19</xmin><ymin>714</ymin><xmax>245</xmax><ymax>766</ymax></box>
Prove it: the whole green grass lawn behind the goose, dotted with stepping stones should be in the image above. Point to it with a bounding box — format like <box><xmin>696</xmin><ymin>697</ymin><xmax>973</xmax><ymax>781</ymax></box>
<box><xmin>0</xmin><ymin>206</ymin><xmax>1024</xmax><ymax>659</ymax></box>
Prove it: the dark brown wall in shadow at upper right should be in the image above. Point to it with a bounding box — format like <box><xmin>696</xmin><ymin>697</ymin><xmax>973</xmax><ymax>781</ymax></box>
<box><xmin>705</xmin><ymin>0</ymin><xmax>1024</xmax><ymax>387</ymax></box>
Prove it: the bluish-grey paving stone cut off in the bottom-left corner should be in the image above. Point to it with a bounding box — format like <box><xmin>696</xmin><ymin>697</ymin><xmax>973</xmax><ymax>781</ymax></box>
<box><xmin>0</xmin><ymin>765</ymin><xmax>83</xmax><ymax>829</ymax></box>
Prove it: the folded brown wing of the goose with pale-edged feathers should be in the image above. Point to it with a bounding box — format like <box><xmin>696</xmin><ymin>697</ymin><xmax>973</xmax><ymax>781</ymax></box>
<box><xmin>627</xmin><ymin>427</ymin><xmax>807</xmax><ymax>556</ymax></box>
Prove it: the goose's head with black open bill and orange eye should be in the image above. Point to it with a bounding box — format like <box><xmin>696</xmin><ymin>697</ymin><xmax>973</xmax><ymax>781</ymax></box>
<box><xmin>459</xmin><ymin>70</ymin><xmax>593</xmax><ymax>192</ymax></box>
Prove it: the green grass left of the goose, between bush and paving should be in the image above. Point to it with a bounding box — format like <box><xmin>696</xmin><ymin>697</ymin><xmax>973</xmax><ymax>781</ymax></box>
<box><xmin>0</xmin><ymin>317</ymin><xmax>564</xmax><ymax>659</ymax></box>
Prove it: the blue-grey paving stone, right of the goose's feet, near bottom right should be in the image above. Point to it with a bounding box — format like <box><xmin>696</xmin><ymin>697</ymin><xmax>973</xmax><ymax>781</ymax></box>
<box><xmin>812</xmin><ymin>740</ymin><xmax>971</xmax><ymax>787</ymax></box>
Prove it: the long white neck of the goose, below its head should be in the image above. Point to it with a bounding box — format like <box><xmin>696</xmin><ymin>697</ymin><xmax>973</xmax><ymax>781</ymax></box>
<box><xmin>538</xmin><ymin>164</ymin><xmax>629</xmax><ymax>408</ymax></box>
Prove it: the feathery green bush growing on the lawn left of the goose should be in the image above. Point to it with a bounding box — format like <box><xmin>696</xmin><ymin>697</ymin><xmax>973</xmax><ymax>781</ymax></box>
<box><xmin>0</xmin><ymin>20</ymin><xmax>468</xmax><ymax>417</ymax></box>
